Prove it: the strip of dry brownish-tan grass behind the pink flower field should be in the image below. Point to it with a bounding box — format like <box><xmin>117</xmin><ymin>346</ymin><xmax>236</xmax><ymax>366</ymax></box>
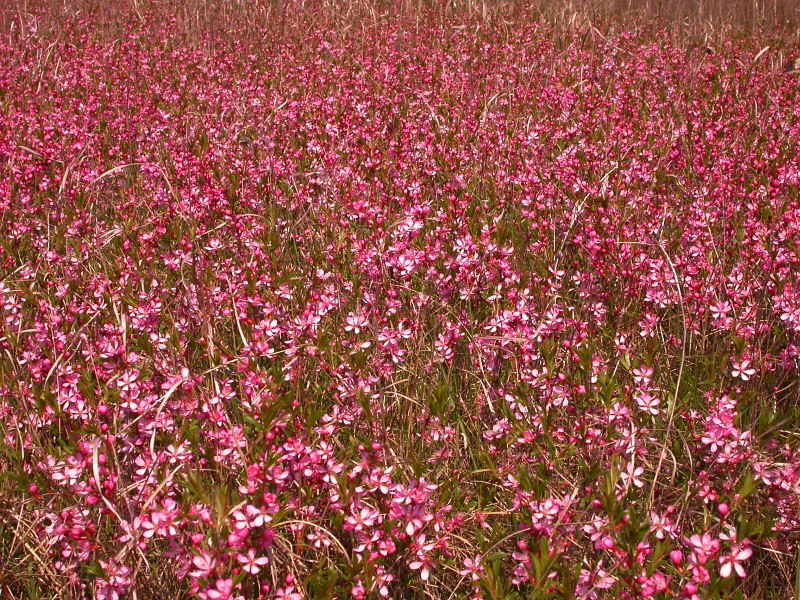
<box><xmin>6</xmin><ymin>0</ymin><xmax>800</xmax><ymax>46</ymax></box>
